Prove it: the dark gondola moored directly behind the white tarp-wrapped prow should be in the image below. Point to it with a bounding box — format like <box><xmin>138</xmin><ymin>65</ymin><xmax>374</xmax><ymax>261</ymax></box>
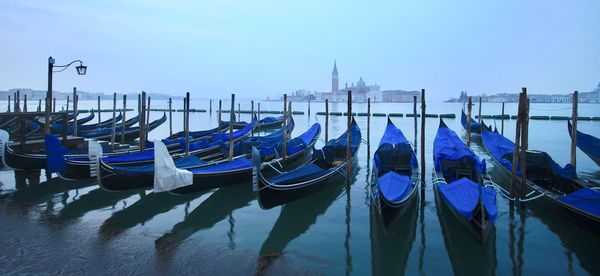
<box><xmin>99</xmin><ymin>119</ymin><xmax>281</xmax><ymax>190</ymax></box>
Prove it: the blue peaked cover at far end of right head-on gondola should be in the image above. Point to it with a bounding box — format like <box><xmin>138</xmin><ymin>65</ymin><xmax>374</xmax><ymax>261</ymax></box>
<box><xmin>433</xmin><ymin>126</ymin><xmax>486</xmax><ymax>173</ymax></box>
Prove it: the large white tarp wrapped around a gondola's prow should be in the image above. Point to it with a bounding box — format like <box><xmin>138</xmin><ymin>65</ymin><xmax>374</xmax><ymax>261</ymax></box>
<box><xmin>154</xmin><ymin>140</ymin><xmax>194</xmax><ymax>193</ymax></box>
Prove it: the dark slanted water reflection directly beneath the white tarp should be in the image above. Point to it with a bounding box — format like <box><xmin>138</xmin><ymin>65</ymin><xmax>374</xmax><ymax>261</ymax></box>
<box><xmin>100</xmin><ymin>190</ymin><xmax>210</xmax><ymax>238</ymax></box>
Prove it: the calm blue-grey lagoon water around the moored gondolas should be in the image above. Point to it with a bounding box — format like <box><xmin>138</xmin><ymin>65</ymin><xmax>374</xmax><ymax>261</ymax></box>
<box><xmin>0</xmin><ymin>100</ymin><xmax>600</xmax><ymax>275</ymax></box>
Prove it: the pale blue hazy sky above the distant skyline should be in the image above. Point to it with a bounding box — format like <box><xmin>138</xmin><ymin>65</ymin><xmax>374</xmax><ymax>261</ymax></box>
<box><xmin>0</xmin><ymin>0</ymin><xmax>600</xmax><ymax>99</ymax></box>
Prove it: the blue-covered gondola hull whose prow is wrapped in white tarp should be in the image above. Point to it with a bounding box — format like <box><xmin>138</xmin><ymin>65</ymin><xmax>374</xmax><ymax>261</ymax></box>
<box><xmin>169</xmin><ymin>123</ymin><xmax>321</xmax><ymax>194</ymax></box>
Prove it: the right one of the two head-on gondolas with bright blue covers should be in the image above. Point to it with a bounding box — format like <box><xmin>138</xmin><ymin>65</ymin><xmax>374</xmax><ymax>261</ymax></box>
<box><xmin>433</xmin><ymin>119</ymin><xmax>497</xmax><ymax>243</ymax></box>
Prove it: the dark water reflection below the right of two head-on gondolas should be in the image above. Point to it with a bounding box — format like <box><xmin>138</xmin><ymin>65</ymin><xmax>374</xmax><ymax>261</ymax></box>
<box><xmin>435</xmin><ymin>189</ymin><xmax>496</xmax><ymax>275</ymax></box>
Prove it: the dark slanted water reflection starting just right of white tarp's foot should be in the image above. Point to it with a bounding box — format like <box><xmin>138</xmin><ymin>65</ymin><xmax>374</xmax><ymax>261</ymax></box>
<box><xmin>155</xmin><ymin>183</ymin><xmax>256</xmax><ymax>253</ymax></box>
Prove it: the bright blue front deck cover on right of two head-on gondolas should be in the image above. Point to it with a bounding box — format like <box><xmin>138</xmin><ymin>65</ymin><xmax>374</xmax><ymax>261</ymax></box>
<box><xmin>438</xmin><ymin>177</ymin><xmax>480</xmax><ymax>221</ymax></box>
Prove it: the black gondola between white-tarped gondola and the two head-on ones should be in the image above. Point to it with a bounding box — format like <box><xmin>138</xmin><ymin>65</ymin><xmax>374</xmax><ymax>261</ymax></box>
<box><xmin>255</xmin><ymin>118</ymin><xmax>361</xmax><ymax>209</ymax></box>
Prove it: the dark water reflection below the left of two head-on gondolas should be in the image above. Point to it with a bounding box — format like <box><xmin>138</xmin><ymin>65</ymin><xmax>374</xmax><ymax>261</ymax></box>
<box><xmin>369</xmin><ymin>195</ymin><xmax>417</xmax><ymax>275</ymax></box>
